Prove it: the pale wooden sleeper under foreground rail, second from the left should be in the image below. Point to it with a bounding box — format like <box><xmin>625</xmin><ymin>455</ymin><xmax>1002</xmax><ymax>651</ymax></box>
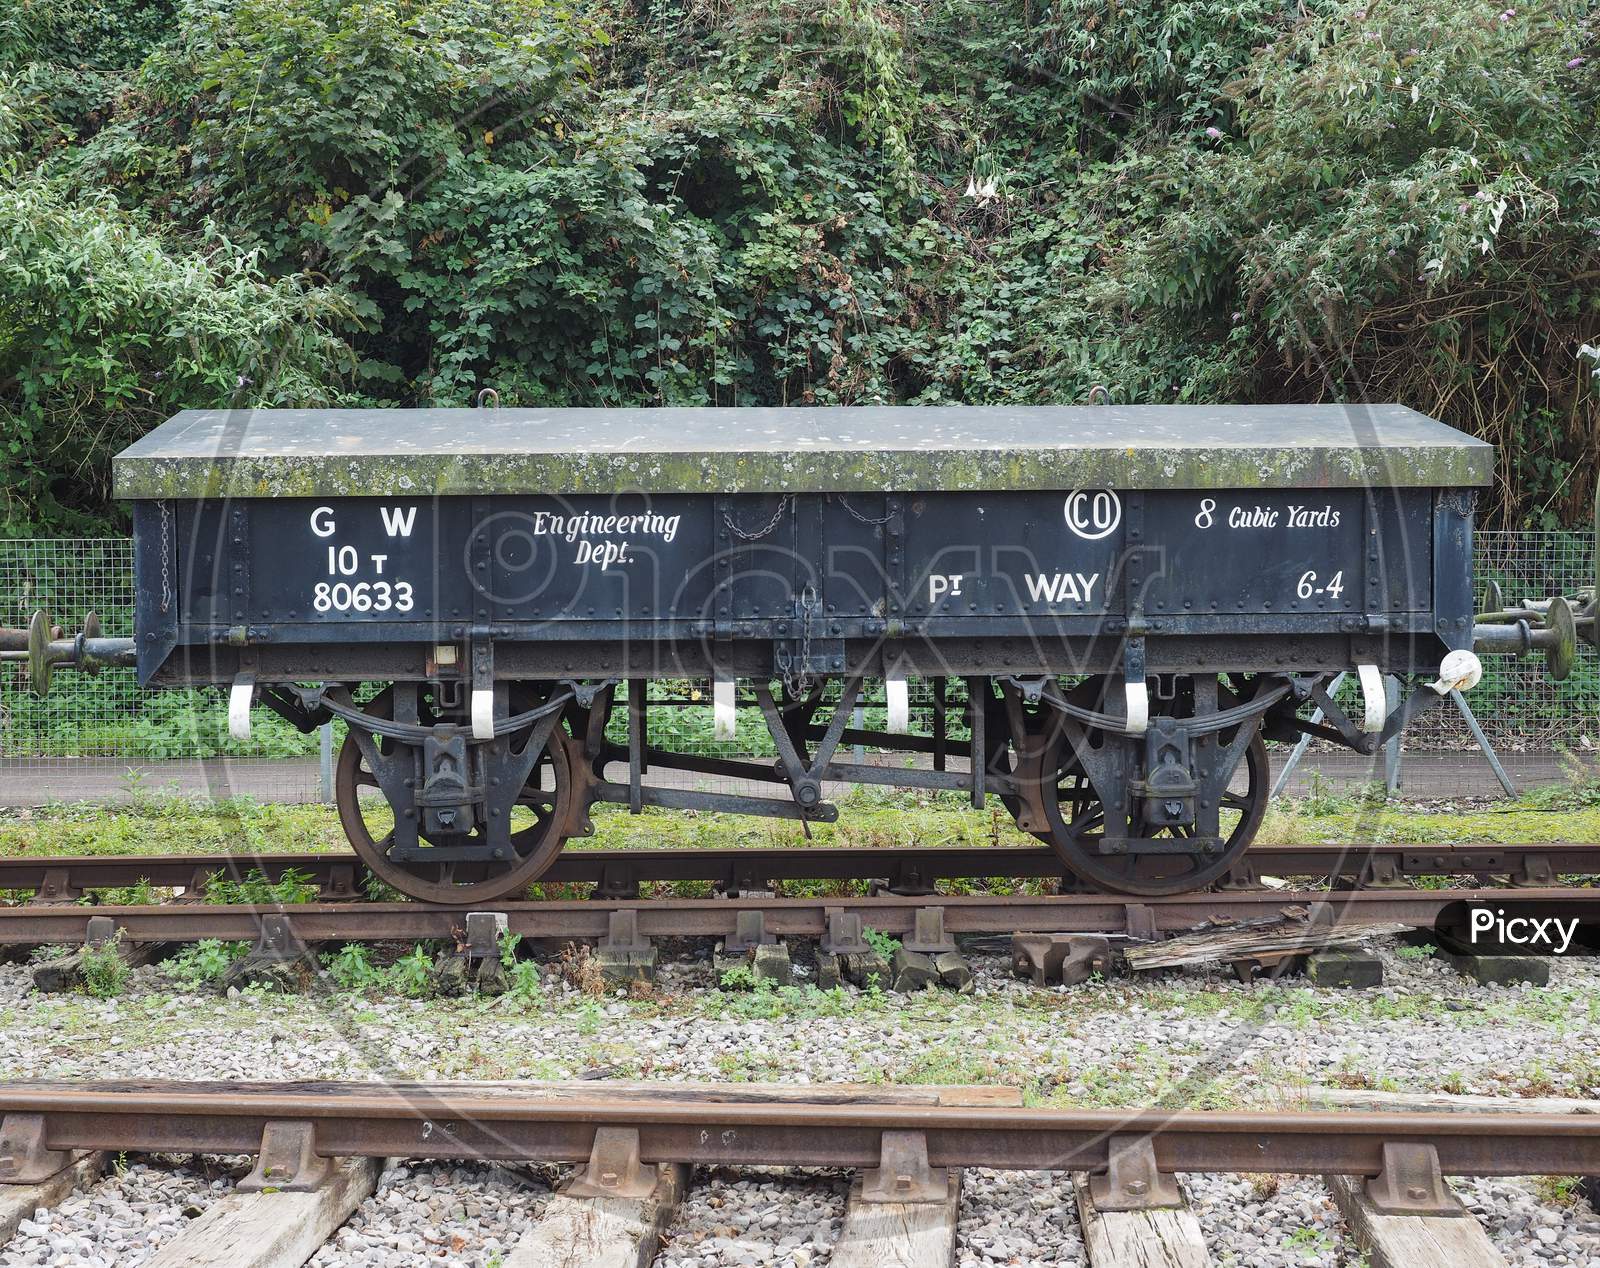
<box><xmin>146</xmin><ymin>1158</ymin><xmax>382</xmax><ymax>1268</ymax></box>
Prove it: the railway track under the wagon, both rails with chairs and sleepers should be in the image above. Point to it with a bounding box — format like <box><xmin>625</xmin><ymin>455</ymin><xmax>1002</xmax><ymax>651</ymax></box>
<box><xmin>0</xmin><ymin>845</ymin><xmax>1600</xmax><ymax>991</ymax></box>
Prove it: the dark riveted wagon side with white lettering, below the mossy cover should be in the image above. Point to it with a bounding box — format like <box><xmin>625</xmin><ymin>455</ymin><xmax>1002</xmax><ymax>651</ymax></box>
<box><xmin>156</xmin><ymin>477</ymin><xmax>1470</xmax><ymax>680</ymax></box>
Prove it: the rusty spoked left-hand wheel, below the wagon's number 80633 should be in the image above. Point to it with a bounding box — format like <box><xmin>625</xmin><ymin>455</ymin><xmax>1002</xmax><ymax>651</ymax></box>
<box><xmin>334</xmin><ymin>690</ymin><xmax>573</xmax><ymax>905</ymax></box>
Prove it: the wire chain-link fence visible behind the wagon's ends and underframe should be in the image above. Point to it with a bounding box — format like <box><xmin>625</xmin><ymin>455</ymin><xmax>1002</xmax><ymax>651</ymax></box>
<box><xmin>0</xmin><ymin>532</ymin><xmax>1600</xmax><ymax>805</ymax></box>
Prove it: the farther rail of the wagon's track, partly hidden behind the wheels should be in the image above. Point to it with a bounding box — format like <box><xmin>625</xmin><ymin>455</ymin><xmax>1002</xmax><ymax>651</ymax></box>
<box><xmin>0</xmin><ymin>842</ymin><xmax>1600</xmax><ymax>897</ymax></box>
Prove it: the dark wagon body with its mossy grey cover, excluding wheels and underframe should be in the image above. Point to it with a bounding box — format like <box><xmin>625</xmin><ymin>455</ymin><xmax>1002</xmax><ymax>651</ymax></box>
<box><xmin>117</xmin><ymin>407</ymin><xmax>1493</xmax><ymax>684</ymax></box>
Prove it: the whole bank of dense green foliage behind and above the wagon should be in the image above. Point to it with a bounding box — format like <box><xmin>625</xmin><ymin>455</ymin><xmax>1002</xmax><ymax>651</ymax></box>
<box><xmin>0</xmin><ymin>0</ymin><xmax>1600</xmax><ymax>535</ymax></box>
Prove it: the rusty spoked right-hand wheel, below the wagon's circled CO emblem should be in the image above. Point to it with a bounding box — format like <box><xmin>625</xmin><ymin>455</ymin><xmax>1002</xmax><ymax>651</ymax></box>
<box><xmin>1035</xmin><ymin>688</ymin><xmax>1270</xmax><ymax>897</ymax></box>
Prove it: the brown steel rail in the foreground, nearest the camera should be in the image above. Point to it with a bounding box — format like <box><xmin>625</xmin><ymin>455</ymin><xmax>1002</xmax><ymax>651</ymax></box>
<box><xmin>0</xmin><ymin>1082</ymin><xmax>1600</xmax><ymax>1175</ymax></box>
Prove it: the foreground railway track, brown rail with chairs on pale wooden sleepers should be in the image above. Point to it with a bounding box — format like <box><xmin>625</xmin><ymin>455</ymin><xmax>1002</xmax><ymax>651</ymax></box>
<box><xmin>0</xmin><ymin>1082</ymin><xmax>1600</xmax><ymax>1268</ymax></box>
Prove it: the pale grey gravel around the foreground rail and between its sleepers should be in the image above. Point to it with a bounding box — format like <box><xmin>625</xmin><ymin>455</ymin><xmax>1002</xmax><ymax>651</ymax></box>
<box><xmin>0</xmin><ymin>948</ymin><xmax>1600</xmax><ymax>1268</ymax></box>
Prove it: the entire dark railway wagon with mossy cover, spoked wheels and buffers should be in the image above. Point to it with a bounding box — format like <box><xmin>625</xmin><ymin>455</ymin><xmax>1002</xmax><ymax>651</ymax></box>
<box><xmin>8</xmin><ymin>405</ymin><xmax>1594</xmax><ymax>903</ymax></box>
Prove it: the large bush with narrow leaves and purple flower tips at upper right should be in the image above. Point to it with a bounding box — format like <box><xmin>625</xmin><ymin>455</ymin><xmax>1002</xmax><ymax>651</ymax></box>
<box><xmin>1117</xmin><ymin>2</ymin><xmax>1600</xmax><ymax>527</ymax></box>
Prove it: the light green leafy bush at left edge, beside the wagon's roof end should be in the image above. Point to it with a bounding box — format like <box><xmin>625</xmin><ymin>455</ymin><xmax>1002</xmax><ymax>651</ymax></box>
<box><xmin>0</xmin><ymin>172</ymin><xmax>349</xmax><ymax>535</ymax></box>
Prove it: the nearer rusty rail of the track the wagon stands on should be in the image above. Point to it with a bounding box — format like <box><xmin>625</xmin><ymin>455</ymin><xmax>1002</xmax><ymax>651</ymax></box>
<box><xmin>0</xmin><ymin>889</ymin><xmax>1600</xmax><ymax>945</ymax></box>
